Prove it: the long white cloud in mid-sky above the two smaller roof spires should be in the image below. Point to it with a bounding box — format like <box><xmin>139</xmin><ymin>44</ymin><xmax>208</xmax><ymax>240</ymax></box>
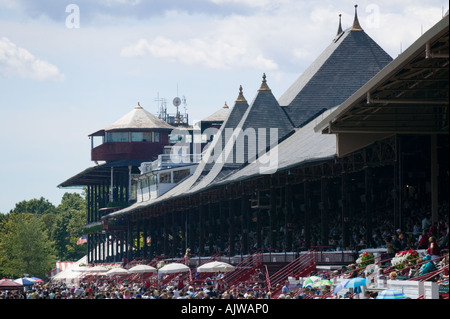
<box><xmin>121</xmin><ymin>36</ymin><xmax>278</xmax><ymax>70</ymax></box>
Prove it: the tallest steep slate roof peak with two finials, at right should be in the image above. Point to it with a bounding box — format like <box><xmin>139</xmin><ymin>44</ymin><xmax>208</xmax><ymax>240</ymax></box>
<box><xmin>278</xmin><ymin>13</ymin><xmax>392</xmax><ymax>127</ymax></box>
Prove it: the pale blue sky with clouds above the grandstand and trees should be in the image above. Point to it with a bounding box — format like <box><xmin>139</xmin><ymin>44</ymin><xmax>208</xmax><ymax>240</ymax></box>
<box><xmin>0</xmin><ymin>0</ymin><xmax>448</xmax><ymax>213</ymax></box>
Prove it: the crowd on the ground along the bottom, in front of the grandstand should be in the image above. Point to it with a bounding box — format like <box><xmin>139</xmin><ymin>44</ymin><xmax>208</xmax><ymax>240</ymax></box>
<box><xmin>0</xmin><ymin>252</ymin><xmax>448</xmax><ymax>299</ymax></box>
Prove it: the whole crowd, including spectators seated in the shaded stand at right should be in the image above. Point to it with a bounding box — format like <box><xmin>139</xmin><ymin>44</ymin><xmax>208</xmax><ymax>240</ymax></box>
<box><xmin>0</xmin><ymin>202</ymin><xmax>449</xmax><ymax>299</ymax></box>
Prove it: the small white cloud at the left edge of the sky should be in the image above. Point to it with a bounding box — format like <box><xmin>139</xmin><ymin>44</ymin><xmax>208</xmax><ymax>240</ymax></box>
<box><xmin>0</xmin><ymin>37</ymin><xmax>64</xmax><ymax>82</ymax></box>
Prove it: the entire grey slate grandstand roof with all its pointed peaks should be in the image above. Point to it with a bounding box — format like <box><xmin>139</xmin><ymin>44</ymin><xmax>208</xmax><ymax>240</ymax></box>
<box><xmin>102</xmin><ymin>10</ymin><xmax>398</xmax><ymax>217</ymax></box>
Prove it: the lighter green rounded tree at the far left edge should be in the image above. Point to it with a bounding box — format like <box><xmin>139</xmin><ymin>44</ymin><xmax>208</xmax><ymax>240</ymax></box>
<box><xmin>0</xmin><ymin>213</ymin><xmax>56</xmax><ymax>277</ymax></box>
